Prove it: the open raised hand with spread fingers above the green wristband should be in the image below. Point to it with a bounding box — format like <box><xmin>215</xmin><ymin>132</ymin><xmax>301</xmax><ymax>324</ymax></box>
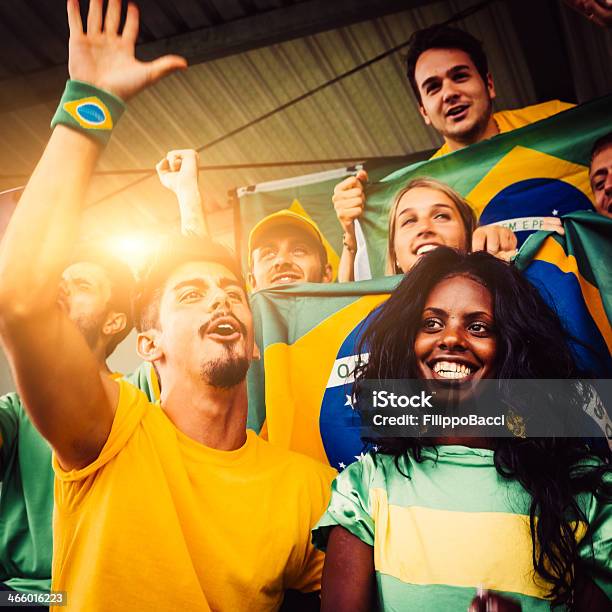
<box><xmin>67</xmin><ymin>0</ymin><xmax>187</xmax><ymax>100</ymax></box>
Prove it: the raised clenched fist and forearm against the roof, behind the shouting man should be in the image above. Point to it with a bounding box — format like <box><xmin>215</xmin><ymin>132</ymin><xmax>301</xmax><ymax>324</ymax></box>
<box><xmin>155</xmin><ymin>149</ymin><xmax>209</xmax><ymax>237</ymax></box>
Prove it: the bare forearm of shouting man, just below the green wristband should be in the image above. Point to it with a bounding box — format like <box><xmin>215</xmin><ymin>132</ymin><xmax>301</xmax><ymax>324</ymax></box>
<box><xmin>0</xmin><ymin>125</ymin><xmax>101</xmax><ymax>313</ymax></box>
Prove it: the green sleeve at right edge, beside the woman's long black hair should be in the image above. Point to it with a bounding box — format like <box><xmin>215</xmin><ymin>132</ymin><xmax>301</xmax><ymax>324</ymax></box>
<box><xmin>578</xmin><ymin>472</ymin><xmax>612</xmax><ymax>599</ymax></box>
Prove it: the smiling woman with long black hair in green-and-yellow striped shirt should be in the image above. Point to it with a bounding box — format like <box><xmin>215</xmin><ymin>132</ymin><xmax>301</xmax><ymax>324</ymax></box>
<box><xmin>314</xmin><ymin>247</ymin><xmax>612</xmax><ymax>612</ymax></box>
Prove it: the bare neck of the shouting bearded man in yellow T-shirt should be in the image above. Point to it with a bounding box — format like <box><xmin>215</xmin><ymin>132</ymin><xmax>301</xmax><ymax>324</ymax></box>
<box><xmin>161</xmin><ymin>379</ymin><xmax>248</xmax><ymax>451</ymax></box>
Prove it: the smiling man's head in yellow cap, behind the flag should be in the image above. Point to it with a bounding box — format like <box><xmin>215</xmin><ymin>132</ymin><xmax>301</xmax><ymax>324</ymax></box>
<box><xmin>248</xmin><ymin>210</ymin><xmax>333</xmax><ymax>291</ymax></box>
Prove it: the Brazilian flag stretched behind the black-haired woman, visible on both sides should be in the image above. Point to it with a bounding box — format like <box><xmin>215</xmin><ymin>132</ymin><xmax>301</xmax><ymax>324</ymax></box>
<box><xmin>249</xmin><ymin>211</ymin><xmax>612</xmax><ymax>469</ymax></box>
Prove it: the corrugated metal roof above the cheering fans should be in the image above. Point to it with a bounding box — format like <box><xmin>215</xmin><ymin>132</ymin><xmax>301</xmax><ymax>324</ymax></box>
<box><xmin>0</xmin><ymin>0</ymin><xmax>612</xmax><ymax>247</ymax></box>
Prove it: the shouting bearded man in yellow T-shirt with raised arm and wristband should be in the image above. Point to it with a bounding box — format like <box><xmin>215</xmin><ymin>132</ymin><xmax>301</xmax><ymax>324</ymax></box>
<box><xmin>0</xmin><ymin>0</ymin><xmax>334</xmax><ymax>612</ymax></box>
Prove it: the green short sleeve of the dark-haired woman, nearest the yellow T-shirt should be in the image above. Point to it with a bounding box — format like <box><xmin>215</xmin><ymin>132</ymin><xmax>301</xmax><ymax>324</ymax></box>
<box><xmin>312</xmin><ymin>455</ymin><xmax>375</xmax><ymax>551</ymax></box>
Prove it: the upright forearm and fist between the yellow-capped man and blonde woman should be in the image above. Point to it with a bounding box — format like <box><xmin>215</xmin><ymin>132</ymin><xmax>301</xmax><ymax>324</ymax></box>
<box><xmin>332</xmin><ymin>170</ymin><xmax>368</xmax><ymax>283</ymax></box>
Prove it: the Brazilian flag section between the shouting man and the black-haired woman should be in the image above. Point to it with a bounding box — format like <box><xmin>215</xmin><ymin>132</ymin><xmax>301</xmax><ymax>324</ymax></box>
<box><xmin>248</xmin><ymin>276</ymin><xmax>401</xmax><ymax>468</ymax></box>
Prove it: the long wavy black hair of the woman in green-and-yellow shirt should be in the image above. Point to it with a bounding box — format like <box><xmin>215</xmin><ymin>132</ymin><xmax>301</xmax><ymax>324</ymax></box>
<box><xmin>353</xmin><ymin>247</ymin><xmax>612</xmax><ymax>607</ymax></box>
